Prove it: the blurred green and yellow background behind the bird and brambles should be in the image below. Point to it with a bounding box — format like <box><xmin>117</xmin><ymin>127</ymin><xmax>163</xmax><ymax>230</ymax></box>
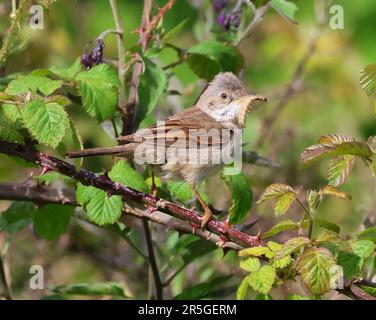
<box><xmin>0</xmin><ymin>0</ymin><xmax>376</xmax><ymax>299</ymax></box>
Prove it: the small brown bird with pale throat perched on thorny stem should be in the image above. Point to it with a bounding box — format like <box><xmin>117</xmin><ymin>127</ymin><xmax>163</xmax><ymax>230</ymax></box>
<box><xmin>67</xmin><ymin>72</ymin><xmax>266</xmax><ymax>228</ymax></box>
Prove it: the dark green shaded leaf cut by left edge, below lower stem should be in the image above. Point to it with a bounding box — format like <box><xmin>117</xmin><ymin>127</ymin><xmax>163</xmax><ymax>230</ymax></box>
<box><xmin>0</xmin><ymin>201</ymin><xmax>36</xmax><ymax>233</ymax></box>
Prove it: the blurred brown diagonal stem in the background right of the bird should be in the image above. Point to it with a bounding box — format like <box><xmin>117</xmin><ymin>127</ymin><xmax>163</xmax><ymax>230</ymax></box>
<box><xmin>256</xmin><ymin>3</ymin><xmax>326</xmax><ymax>148</ymax></box>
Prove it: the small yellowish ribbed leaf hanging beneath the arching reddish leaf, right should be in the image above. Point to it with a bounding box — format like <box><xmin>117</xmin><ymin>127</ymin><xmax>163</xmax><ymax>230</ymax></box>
<box><xmin>327</xmin><ymin>155</ymin><xmax>355</xmax><ymax>187</ymax></box>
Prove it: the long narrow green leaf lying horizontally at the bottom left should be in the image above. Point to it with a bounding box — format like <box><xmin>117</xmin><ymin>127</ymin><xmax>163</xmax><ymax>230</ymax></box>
<box><xmin>51</xmin><ymin>282</ymin><xmax>126</xmax><ymax>298</ymax></box>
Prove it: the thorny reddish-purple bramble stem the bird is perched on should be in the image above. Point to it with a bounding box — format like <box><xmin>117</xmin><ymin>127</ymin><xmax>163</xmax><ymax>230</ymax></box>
<box><xmin>0</xmin><ymin>141</ymin><xmax>262</xmax><ymax>247</ymax></box>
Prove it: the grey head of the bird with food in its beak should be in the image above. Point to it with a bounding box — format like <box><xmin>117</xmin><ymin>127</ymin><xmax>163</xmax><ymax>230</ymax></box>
<box><xmin>196</xmin><ymin>72</ymin><xmax>267</xmax><ymax>128</ymax></box>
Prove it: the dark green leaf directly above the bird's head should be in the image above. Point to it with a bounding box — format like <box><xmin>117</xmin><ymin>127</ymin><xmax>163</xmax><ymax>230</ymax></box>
<box><xmin>187</xmin><ymin>40</ymin><xmax>244</xmax><ymax>81</ymax></box>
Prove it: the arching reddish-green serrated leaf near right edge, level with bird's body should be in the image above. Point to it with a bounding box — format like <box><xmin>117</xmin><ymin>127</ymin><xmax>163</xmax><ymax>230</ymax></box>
<box><xmin>300</xmin><ymin>134</ymin><xmax>372</xmax><ymax>166</ymax></box>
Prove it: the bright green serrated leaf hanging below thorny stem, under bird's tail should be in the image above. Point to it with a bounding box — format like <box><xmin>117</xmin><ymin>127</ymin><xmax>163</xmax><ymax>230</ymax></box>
<box><xmin>86</xmin><ymin>189</ymin><xmax>123</xmax><ymax>225</ymax></box>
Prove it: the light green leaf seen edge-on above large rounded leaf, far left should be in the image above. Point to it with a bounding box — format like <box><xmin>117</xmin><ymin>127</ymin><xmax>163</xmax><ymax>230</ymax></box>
<box><xmin>5</xmin><ymin>75</ymin><xmax>62</xmax><ymax>96</ymax></box>
